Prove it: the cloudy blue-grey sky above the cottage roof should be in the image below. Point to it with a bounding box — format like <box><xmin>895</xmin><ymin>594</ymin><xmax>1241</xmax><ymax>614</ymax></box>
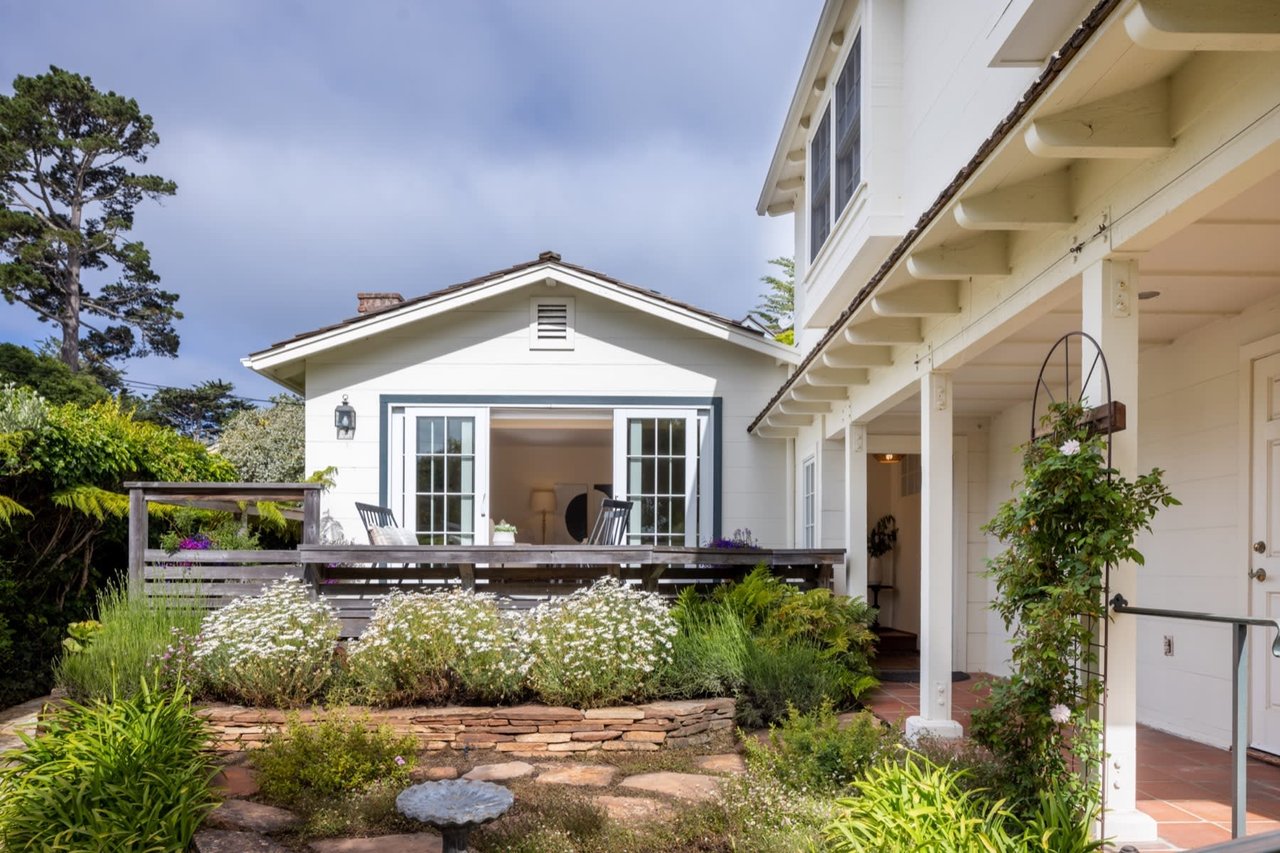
<box><xmin>0</xmin><ymin>0</ymin><xmax>822</xmax><ymax>397</ymax></box>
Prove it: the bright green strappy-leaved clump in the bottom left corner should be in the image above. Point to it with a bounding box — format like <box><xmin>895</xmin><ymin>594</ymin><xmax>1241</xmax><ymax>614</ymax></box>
<box><xmin>0</xmin><ymin>688</ymin><xmax>215</xmax><ymax>853</ymax></box>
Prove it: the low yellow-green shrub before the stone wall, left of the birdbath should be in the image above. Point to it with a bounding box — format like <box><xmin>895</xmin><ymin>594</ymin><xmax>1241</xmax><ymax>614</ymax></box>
<box><xmin>252</xmin><ymin>712</ymin><xmax>417</xmax><ymax>807</ymax></box>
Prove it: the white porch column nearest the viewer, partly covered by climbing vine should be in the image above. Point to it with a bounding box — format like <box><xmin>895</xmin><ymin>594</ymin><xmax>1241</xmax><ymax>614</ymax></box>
<box><xmin>1082</xmin><ymin>260</ymin><xmax>1156</xmax><ymax>841</ymax></box>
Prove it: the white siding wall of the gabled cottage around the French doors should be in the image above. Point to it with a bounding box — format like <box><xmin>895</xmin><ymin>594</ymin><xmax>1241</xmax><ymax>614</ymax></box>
<box><xmin>307</xmin><ymin>286</ymin><xmax>786</xmax><ymax>544</ymax></box>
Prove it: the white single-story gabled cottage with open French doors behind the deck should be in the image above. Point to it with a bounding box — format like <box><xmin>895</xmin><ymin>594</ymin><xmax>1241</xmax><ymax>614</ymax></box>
<box><xmin>244</xmin><ymin>252</ymin><xmax>799</xmax><ymax>546</ymax></box>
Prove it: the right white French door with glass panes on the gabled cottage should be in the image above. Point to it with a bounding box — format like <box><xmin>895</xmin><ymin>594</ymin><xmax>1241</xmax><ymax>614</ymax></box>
<box><xmin>613</xmin><ymin>409</ymin><xmax>713</xmax><ymax>547</ymax></box>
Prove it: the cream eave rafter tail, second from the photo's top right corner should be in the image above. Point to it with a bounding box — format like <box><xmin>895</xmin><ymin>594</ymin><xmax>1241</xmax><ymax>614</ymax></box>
<box><xmin>1025</xmin><ymin>79</ymin><xmax>1174</xmax><ymax>159</ymax></box>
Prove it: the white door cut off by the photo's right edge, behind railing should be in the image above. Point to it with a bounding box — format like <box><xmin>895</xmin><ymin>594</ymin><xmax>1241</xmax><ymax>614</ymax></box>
<box><xmin>1248</xmin><ymin>353</ymin><xmax>1280</xmax><ymax>754</ymax></box>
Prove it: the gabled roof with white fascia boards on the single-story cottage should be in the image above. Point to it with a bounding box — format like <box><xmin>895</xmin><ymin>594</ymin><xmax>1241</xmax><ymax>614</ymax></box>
<box><xmin>241</xmin><ymin>252</ymin><xmax>800</xmax><ymax>391</ymax></box>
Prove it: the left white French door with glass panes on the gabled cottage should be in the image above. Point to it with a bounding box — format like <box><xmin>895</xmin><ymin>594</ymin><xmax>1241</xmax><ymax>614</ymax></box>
<box><xmin>388</xmin><ymin>406</ymin><xmax>489</xmax><ymax>544</ymax></box>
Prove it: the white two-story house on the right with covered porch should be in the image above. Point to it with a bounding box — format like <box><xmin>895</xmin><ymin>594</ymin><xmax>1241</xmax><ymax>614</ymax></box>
<box><xmin>749</xmin><ymin>0</ymin><xmax>1280</xmax><ymax>840</ymax></box>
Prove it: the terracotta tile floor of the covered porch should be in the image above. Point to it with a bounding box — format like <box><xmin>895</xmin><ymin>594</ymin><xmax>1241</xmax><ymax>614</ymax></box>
<box><xmin>868</xmin><ymin>672</ymin><xmax>1280</xmax><ymax>850</ymax></box>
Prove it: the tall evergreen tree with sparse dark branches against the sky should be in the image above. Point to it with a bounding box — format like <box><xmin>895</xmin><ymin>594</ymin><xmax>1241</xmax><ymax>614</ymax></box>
<box><xmin>0</xmin><ymin>67</ymin><xmax>182</xmax><ymax>370</ymax></box>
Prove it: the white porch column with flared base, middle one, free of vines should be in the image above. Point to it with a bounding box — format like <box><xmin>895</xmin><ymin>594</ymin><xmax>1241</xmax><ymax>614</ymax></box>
<box><xmin>906</xmin><ymin>371</ymin><xmax>964</xmax><ymax>739</ymax></box>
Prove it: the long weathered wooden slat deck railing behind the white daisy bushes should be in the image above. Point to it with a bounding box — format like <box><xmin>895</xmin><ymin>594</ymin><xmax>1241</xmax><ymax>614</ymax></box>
<box><xmin>143</xmin><ymin>544</ymin><xmax>844</xmax><ymax>637</ymax></box>
